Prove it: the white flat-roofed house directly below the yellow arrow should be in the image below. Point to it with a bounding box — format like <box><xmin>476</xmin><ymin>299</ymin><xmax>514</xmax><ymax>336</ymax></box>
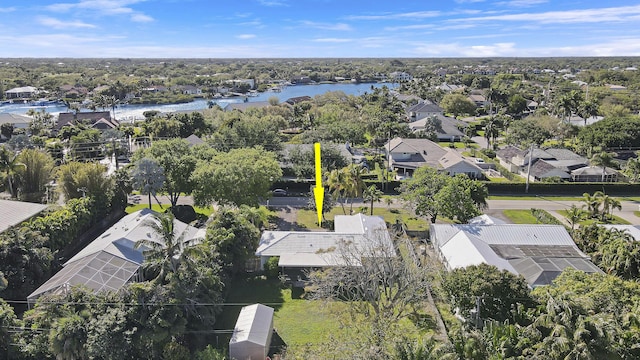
<box><xmin>256</xmin><ymin>214</ymin><xmax>395</xmax><ymax>267</ymax></box>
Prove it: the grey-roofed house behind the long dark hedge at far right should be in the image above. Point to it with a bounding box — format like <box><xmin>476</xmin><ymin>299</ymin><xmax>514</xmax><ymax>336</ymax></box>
<box><xmin>496</xmin><ymin>145</ymin><xmax>589</xmax><ymax>182</ymax></box>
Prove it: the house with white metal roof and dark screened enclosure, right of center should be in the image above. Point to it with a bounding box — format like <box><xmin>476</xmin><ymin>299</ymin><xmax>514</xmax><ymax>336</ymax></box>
<box><xmin>429</xmin><ymin>224</ymin><xmax>602</xmax><ymax>288</ymax></box>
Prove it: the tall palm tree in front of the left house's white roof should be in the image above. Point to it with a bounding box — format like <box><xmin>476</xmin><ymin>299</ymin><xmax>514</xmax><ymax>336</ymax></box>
<box><xmin>135</xmin><ymin>212</ymin><xmax>199</xmax><ymax>284</ymax></box>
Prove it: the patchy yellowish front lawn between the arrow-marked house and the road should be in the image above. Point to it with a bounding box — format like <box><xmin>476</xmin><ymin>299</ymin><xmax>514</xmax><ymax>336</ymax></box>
<box><xmin>297</xmin><ymin>204</ymin><xmax>429</xmax><ymax>231</ymax></box>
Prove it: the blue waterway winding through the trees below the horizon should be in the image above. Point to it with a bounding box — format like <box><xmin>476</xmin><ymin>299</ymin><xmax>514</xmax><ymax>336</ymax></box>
<box><xmin>0</xmin><ymin>83</ymin><xmax>397</xmax><ymax>121</ymax></box>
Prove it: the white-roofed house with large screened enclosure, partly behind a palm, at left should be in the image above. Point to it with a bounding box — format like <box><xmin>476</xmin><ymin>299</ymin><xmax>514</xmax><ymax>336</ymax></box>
<box><xmin>27</xmin><ymin>209</ymin><xmax>200</xmax><ymax>302</ymax></box>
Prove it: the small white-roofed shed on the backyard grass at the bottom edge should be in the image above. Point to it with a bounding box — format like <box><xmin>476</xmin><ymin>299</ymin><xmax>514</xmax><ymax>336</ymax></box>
<box><xmin>229</xmin><ymin>304</ymin><xmax>273</xmax><ymax>360</ymax></box>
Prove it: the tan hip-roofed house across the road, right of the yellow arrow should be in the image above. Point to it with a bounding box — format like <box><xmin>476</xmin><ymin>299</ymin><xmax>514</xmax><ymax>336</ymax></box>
<box><xmin>385</xmin><ymin>138</ymin><xmax>483</xmax><ymax>179</ymax></box>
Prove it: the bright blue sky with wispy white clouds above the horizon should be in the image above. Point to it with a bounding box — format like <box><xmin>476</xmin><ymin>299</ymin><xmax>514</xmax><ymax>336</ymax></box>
<box><xmin>0</xmin><ymin>0</ymin><xmax>640</xmax><ymax>58</ymax></box>
